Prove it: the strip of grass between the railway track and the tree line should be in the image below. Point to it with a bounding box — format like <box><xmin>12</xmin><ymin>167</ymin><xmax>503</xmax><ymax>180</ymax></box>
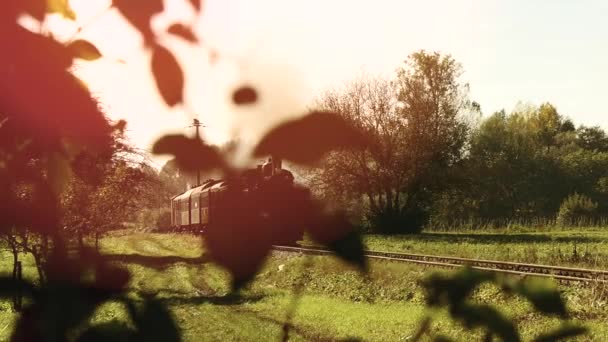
<box><xmin>365</xmin><ymin>227</ymin><xmax>608</xmax><ymax>269</ymax></box>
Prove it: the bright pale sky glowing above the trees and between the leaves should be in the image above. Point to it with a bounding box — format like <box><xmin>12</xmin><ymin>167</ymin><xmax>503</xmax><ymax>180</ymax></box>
<box><xmin>40</xmin><ymin>0</ymin><xmax>608</xmax><ymax>166</ymax></box>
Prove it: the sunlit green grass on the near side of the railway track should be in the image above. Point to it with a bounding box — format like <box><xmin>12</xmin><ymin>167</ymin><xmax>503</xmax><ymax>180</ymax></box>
<box><xmin>0</xmin><ymin>234</ymin><xmax>608</xmax><ymax>341</ymax></box>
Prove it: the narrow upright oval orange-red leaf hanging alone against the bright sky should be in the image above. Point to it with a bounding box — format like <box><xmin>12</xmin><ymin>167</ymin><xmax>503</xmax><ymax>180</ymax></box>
<box><xmin>152</xmin><ymin>45</ymin><xmax>184</xmax><ymax>106</ymax></box>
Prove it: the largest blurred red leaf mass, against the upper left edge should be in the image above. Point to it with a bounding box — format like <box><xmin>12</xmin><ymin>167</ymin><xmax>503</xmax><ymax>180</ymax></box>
<box><xmin>0</xmin><ymin>25</ymin><xmax>110</xmax><ymax>150</ymax></box>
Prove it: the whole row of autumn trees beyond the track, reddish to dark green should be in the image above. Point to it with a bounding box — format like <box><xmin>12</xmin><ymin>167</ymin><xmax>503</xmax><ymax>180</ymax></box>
<box><xmin>305</xmin><ymin>51</ymin><xmax>608</xmax><ymax>233</ymax></box>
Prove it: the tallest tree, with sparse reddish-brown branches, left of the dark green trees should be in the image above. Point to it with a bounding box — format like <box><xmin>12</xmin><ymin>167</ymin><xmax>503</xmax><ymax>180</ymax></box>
<box><xmin>311</xmin><ymin>51</ymin><xmax>478</xmax><ymax>232</ymax></box>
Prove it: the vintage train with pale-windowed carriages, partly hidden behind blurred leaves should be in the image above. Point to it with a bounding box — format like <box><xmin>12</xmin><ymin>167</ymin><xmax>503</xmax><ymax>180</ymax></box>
<box><xmin>170</xmin><ymin>158</ymin><xmax>294</xmax><ymax>234</ymax></box>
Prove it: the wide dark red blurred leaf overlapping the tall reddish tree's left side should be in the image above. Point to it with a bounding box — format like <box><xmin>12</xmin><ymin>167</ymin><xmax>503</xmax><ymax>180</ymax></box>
<box><xmin>254</xmin><ymin>112</ymin><xmax>369</xmax><ymax>164</ymax></box>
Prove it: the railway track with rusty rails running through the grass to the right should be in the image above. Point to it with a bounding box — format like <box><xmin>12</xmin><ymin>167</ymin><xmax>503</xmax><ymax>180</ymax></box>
<box><xmin>273</xmin><ymin>246</ymin><xmax>608</xmax><ymax>284</ymax></box>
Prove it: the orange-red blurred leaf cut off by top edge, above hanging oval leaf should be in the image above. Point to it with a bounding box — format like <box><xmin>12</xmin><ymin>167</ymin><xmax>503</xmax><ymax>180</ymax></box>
<box><xmin>113</xmin><ymin>0</ymin><xmax>164</xmax><ymax>45</ymax></box>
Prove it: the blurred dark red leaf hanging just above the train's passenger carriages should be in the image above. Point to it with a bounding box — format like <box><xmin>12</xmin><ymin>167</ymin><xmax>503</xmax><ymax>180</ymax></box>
<box><xmin>152</xmin><ymin>135</ymin><xmax>224</xmax><ymax>171</ymax></box>
